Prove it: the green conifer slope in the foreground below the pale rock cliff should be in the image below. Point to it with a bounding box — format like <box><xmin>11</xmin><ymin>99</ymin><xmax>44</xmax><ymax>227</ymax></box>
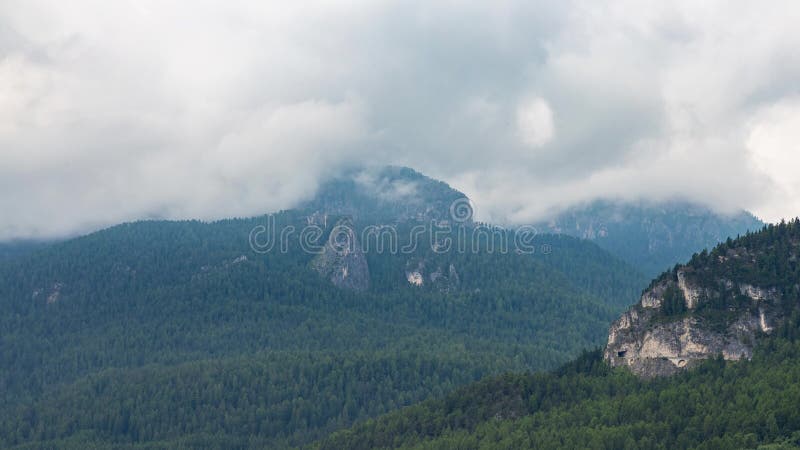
<box><xmin>314</xmin><ymin>336</ymin><xmax>800</xmax><ymax>450</ymax></box>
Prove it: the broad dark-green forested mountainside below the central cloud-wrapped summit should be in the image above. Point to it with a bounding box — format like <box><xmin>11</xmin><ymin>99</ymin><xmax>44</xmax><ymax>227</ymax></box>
<box><xmin>0</xmin><ymin>183</ymin><xmax>645</xmax><ymax>448</ymax></box>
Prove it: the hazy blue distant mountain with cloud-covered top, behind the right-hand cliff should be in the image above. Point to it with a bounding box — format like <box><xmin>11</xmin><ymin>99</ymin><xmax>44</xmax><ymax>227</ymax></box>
<box><xmin>536</xmin><ymin>200</ymin><xmax>764</xmax><ymax>277</ymax></box>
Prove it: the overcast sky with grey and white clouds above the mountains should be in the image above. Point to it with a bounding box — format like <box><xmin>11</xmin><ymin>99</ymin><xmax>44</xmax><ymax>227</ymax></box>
<box><xmin>0</xmin><ymin>0</ymin><xmax>800</xmax><ymax>239</ymax></box>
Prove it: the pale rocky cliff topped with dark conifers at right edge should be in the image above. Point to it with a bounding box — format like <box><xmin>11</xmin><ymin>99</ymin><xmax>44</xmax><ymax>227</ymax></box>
<box><xmin>604</xmin><ymin>223</ymin><xmax>800</xmax><ymax>377</ymax></box>
